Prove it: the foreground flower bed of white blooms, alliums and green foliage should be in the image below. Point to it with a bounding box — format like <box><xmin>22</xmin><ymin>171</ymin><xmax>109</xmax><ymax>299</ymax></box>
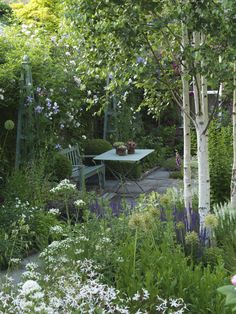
<box><xmin>0</xmin><ymin>180</ymin><xmax>234</xmax><ymax>314</ymax></box>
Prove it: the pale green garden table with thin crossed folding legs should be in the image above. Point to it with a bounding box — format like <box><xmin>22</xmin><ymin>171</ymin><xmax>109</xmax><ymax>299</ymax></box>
<box><xmin>93</xmin><ymin>149</ymin><xmax>154</xmax><ymax>193</ymax></box>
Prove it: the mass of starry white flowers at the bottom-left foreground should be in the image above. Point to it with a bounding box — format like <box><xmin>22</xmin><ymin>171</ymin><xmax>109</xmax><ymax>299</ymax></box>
<box><xmin>0</xmin><ymin>238</ymin><xmax>186</xmax><ymax>314</ymax></box>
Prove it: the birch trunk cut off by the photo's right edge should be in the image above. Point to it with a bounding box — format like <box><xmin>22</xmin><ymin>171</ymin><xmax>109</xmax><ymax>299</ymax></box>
<box><xmin>231</xmin><ymin>61</ymin><xmax>236</xmax><ymax>209</ymax></box>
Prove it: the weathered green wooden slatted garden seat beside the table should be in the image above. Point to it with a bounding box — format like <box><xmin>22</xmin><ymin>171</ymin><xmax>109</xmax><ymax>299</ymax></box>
<box><xmin>60</xmin><ymin>145</ymin><xmax>105</xmax><ymax>189</ymax></box>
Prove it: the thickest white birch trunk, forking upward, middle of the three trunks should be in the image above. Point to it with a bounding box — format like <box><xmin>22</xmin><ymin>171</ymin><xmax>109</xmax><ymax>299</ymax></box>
<box><xmin>193</xmin><ymin>33</ymin><xmax>210</xmax><ymax>243</ymax></box>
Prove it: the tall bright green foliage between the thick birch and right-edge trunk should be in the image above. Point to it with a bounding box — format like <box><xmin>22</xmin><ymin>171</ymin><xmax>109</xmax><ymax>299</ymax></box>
<box><xmin>209</xmin><ymin>121</ymin><xmax>233</xmax><ymax>204</ymax></box>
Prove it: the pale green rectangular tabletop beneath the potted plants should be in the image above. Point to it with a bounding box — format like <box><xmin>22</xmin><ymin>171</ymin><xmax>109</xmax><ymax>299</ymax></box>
<box><xmin>93</xmin><ymin>149</ymin><xmax>154</xmax><ymax>162</ymax></box>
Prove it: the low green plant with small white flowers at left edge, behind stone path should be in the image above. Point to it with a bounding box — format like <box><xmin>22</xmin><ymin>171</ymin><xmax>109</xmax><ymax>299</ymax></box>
<box><xmin>0</xmin><ymin>198</ymin><xmax>60</xmax><ymax>268</ymax></box>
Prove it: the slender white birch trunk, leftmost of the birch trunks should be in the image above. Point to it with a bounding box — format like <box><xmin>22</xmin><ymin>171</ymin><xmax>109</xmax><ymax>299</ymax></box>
<box><xmin>182</xmin><ymin>24</ymin><xmax>192</xmax><ymax>230</ymax></box>
